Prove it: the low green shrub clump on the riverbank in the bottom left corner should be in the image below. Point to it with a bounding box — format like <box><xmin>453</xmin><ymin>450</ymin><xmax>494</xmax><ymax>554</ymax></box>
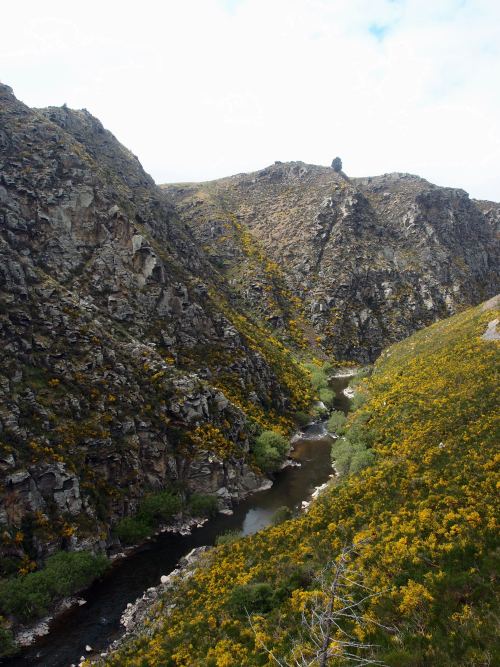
<box><xmin>0</xmin><ymin>551</ymin><xmax>109</xmax><ymax>621</ymax></box>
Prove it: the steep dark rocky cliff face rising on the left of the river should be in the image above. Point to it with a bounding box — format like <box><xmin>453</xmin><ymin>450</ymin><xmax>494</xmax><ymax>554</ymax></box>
<box><xmin>0</xmin><ymin>81</ymin><xmax>307</xmax><ymax>567</ymax></box>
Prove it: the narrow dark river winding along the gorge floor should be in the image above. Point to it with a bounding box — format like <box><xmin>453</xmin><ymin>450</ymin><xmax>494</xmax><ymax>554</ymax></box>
<box><xmin>0</xmin><ymin>377</ymin><xmax>349</xmax><ymax>667</ymax></box>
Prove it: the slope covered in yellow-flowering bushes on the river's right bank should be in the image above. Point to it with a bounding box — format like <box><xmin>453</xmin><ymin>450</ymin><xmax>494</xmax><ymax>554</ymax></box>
<box><xmin>102</xmin><ymin>300</ymin><xmax>500</xmax><ymax>667</ymax></box>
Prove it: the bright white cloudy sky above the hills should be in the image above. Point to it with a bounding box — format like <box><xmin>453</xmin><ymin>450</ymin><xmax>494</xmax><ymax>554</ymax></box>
<box><xmin>0</xmin><ymin>0</ymin><xmax>500</xmax><ymax>201</ymax></box>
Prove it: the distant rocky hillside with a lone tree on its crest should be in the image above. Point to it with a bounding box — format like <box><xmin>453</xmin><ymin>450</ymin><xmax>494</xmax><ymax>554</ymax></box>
<box><xmin>163</xmin><ymin>162</ymin><xmax>498</xmax><ymax>362</ymax></box>
